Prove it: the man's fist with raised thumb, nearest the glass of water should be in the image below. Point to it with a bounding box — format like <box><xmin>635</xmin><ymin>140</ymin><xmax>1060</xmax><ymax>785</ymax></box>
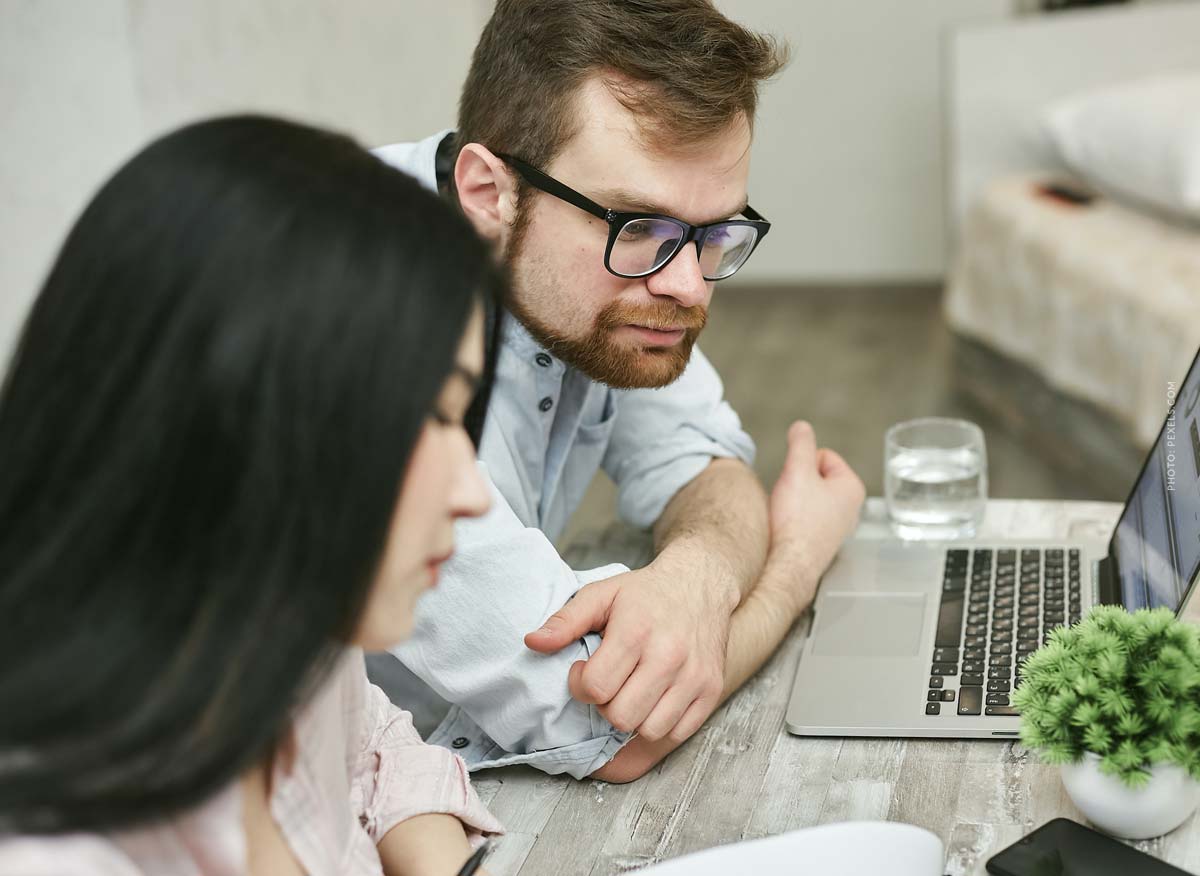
<box><xmin>760</xmin><ymin>421</ymin><xmax>866</xmax><ymax>614</ymax></box>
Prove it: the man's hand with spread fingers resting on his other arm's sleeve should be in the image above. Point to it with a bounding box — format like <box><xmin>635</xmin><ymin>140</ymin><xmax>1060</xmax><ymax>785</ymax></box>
<box><xmin>524</xmin><ymin>556</ymin><xmax>736</xmax><ymax>743</ymax></box>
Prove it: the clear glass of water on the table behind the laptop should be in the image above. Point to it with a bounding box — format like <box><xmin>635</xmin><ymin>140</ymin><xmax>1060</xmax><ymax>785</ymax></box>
<box><xmin>883</xmin><ymin>416</ymin><xmax>988</xmax><ymax>539</ymax></box>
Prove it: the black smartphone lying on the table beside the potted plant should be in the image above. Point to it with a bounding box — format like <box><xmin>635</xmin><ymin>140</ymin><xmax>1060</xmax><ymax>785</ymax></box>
<box><xmin>988</xmin><ymin>818</ymin><xmax>1190</xmax><ymax>876</ymax></box>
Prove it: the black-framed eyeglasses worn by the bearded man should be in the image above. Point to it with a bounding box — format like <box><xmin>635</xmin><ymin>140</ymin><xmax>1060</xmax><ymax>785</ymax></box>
<box><xmin>496</xmin><ymin>152</ymin><xmax>770</xmax><ymax>281</ymax></box>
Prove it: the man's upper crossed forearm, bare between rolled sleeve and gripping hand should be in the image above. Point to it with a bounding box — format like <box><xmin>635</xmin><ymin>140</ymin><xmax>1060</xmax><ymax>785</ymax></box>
<box><xmin>654</xmin><ymin>460</ymin><xmax>768</xmax><ymax>607</ymax></box>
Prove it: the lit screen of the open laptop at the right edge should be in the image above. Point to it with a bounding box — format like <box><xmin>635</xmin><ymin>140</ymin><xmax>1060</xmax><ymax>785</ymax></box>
<box><xmin>1109</xmin><ymin>355</ymin><xmax>1200</xmax><ymax>611</ymax></box>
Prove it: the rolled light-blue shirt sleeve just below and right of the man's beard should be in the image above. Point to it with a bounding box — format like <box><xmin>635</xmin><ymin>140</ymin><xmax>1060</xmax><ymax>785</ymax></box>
<box><xmin>602</xmin><ymin>347</ymin><xmax>755</xmax><ymax>529</ymax></box>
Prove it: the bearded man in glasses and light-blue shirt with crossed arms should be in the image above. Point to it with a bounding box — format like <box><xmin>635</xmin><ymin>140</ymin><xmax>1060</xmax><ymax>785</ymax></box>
<box><xmin>374</xmin><ymin>0</ymin><xmax>863</xmax><ymax>781</ymax></box>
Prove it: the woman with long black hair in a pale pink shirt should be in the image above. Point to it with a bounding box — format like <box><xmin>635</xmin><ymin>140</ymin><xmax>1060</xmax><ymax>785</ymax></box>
<box><xmin>0</xmin><ymin>118</ymin><xmax>500</xmax><ymax>876</ymax></box>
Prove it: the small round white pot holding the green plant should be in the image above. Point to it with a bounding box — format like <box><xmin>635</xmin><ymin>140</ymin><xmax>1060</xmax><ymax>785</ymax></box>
<box><xmin>1062</xmin><ymin>751</ymin><xmax>1200</xmax><ymax>840</ymax></box>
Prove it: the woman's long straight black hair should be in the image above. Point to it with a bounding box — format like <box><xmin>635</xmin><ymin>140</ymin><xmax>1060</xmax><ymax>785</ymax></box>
<box><xmin>0</xmin><ymin>116</ymin><xmax>500</xmax><ymax>834</ymax></box>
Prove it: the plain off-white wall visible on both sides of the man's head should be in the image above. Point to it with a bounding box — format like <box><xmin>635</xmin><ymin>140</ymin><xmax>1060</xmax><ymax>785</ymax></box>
<box><xmin>0</xmin><ymin>0</ymin><xmax>1015</xmax><ymax>362</ymax></box>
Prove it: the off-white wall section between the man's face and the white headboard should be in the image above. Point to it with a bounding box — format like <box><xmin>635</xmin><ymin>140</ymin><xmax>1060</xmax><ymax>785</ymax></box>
<box><xmin>720</xmin><ymin>0</ymin><xmax>1013</xmax><ymax>282</ymax></box>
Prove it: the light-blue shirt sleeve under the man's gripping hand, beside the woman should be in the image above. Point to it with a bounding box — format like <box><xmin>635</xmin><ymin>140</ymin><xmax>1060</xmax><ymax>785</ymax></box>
<box><xmin>392</xmin><ymin>463</ymin><xmax>629</xmax><ymax>779</ymax></box>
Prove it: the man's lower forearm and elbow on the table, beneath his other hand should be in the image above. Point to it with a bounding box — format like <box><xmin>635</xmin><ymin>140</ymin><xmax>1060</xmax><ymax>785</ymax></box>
<box><xmin>592</xmin><ymin>552</ymin><xmax>818</xmax><ymax>782</ymax></box>
